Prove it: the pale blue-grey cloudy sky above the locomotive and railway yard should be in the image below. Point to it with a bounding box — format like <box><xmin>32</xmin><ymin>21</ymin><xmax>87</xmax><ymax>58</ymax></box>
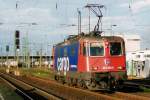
<box><xmin>0</xmin><ymin>0</ymin><xmax>150</xmax><ymax>54</ymax></box>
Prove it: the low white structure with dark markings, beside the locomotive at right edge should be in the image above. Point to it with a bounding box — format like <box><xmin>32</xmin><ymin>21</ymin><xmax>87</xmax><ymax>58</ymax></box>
<box><xmin>127</xmin><ymin>50</ymin><xmax>150</xmax><ymax>78</ymax></box>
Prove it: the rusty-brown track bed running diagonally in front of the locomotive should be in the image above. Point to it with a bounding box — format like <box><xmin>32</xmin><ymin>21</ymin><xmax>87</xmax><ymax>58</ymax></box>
<box><xmin>1</xmin><ymin>72</ymin><xmax>150</xmax><ymax>100</ymax></box>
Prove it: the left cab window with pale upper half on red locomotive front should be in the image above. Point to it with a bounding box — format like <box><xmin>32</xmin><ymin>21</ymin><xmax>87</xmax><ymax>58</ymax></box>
<box><xmin>90</xmin><ymin>43</ymin><xmax>104</xmax><ymax>56</ymax></box>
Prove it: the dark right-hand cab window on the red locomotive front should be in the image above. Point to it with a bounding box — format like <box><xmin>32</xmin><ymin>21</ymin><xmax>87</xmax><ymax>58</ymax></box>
<box><xmin>110</xmin><ymin>42</ymin><xmax>122</xmax><ymax>56</ymax></box>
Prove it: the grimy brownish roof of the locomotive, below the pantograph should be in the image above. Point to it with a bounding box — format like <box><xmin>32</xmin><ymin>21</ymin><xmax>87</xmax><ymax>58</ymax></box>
<box><xmin>56</xmin><ymin>34</ymin><xmax>123</xmax><ymax>46</ymax></box>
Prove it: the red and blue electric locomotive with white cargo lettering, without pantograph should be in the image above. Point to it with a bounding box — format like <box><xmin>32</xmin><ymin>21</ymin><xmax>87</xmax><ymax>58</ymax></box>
<box><xmin>53</xmin><ymin>32</ymin><xmax>127</xmax><ymax>90</ymax></box>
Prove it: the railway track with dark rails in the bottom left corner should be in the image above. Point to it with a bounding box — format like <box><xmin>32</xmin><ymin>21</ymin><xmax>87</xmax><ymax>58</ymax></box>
<box><xmin>0</xmin><ymin>74</ymin><xmax>61</xmax><ymax>100</ymax></box>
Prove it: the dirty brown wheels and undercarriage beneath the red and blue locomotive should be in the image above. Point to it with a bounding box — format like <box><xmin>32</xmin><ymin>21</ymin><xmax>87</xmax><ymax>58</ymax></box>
<box><xmin>55</xmin><ymin>72</ymin><xmax>126</xmax><ymax>90</ymax></box>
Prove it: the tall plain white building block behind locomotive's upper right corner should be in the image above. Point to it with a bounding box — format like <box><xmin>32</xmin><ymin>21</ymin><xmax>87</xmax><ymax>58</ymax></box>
<box><xmin>117</xmin><ymin>34</ymin><xmax>141</xmax><ymax>53</ymax></box>
